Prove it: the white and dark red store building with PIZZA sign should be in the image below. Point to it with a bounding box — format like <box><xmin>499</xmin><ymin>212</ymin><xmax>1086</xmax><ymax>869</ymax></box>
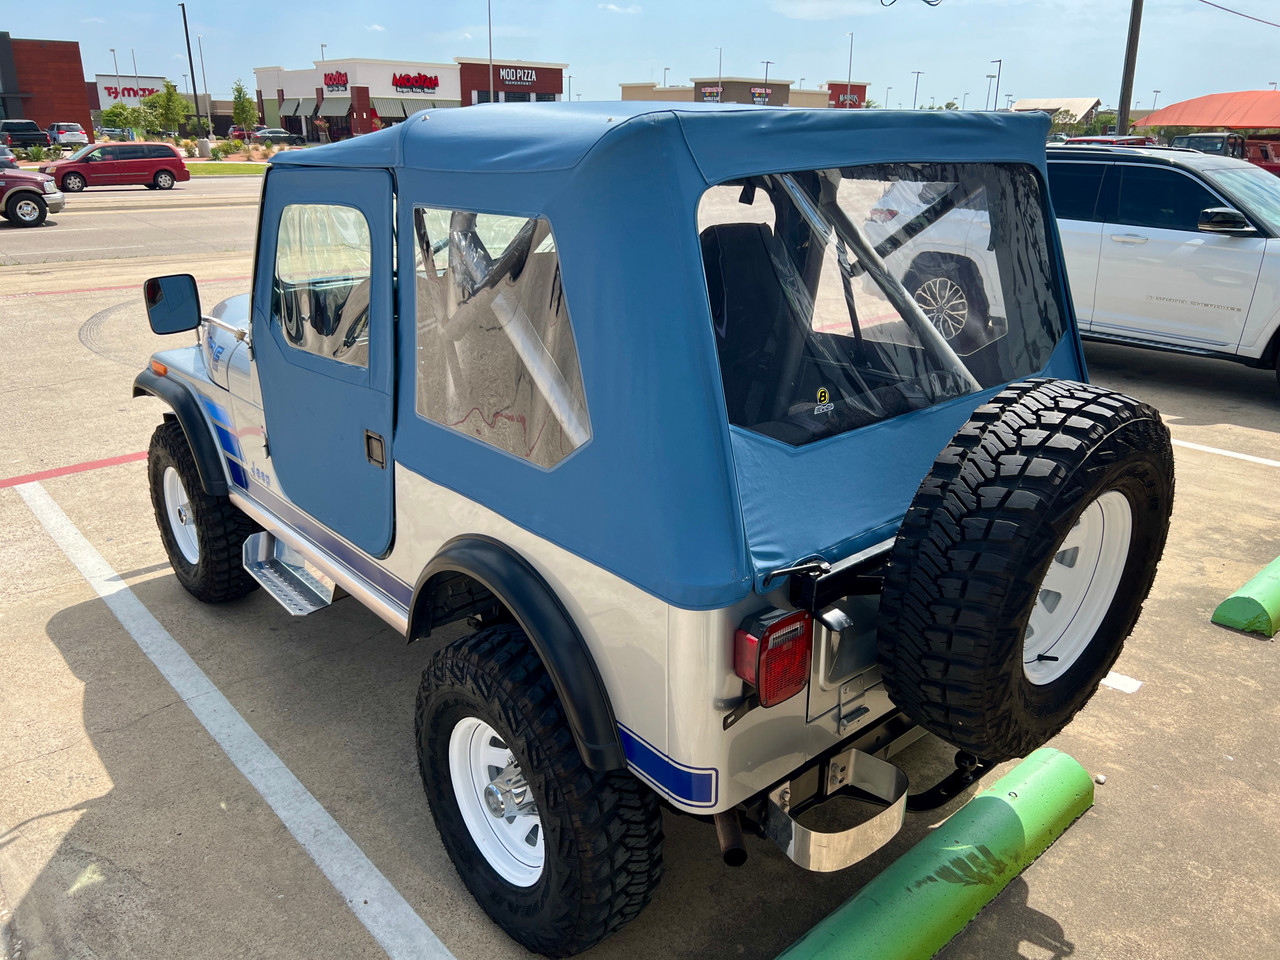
<box><xmin>253</xmin><ymin>56</ymin><xmax>568</xmax><ymax>140</ymax></box>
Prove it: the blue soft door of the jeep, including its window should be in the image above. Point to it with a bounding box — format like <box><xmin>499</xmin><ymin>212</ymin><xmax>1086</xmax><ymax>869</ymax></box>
<box><xmin>252</xmin><ymin>165</ymin><xmax>394</xmax><ymax>557</ymax></box>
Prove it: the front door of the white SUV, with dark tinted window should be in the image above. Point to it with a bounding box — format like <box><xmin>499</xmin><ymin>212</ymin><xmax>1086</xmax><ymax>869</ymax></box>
<box><xmin>1089</xmin><ymin>164</ymin><xmax>1266</xmax><ymax>352</ymax></box>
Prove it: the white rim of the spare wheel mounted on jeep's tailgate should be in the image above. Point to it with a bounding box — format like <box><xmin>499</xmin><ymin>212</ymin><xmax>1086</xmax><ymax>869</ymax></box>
<box><xmin>1023</xmin><ymin>490</ymin><xmax>1133</xmax><ymax>685</ymax></box>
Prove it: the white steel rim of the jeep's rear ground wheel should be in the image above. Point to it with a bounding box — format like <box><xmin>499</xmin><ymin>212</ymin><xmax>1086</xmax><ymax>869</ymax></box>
<box><xmin>449</xmin><ymin>717</ymin><xmax>547</xmax><ymax>887</ymax></box>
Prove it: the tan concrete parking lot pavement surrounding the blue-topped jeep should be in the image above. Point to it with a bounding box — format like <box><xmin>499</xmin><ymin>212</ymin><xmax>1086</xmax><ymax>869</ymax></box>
<box><xmin>0</xmin><ymin>179</ymin><xmax>1280</xmax><ymax>960</ymax></box>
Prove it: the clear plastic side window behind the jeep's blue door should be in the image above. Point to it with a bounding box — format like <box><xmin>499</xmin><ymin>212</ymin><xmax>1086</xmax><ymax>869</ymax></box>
<box><xmin>413</xmin><ymin>206</ymin><xmax>591</xmax><ymax>467</ymax></box>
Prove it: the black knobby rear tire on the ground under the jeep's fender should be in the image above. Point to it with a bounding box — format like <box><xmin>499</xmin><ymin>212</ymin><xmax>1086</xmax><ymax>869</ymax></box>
<box><xmin>415</xmin><ymin>623</ymin><xmax>663</xmax><ymax>956</ymax></box>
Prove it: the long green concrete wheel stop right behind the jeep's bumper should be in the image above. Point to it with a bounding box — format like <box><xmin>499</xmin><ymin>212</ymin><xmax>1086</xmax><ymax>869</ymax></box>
<box><xmin>778</xmin><ymin>748</ymin><xmax>1093</xmax><ymax>960</ymax></box>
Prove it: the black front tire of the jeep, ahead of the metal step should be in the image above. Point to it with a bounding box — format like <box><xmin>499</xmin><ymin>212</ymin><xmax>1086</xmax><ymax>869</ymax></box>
<box><xmin>147</xmin><ymin>420</ymin><xmax>261</xmax><ymax>603</ymax></box>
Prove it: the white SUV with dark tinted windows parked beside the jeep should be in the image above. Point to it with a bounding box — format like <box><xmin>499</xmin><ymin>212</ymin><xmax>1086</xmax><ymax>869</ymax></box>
<box><xmin>1048</xmin><ymin>147</ymin><xmax>1280</xmax><ymax>381</ymax></box>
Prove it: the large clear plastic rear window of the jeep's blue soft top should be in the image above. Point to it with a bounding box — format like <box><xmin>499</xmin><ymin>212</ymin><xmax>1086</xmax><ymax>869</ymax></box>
<box><xmin>698</xmin><ymin>164</ymin><xmax>1065</xmax><ymax>445</ymax></box>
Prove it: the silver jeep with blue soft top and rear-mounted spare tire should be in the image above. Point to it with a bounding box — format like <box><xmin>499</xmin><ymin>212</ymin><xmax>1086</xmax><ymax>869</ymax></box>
<box><xmin>133</xmin><ymin>102</ymin><xmax>1172</xmax><ymax>956</ymax></box>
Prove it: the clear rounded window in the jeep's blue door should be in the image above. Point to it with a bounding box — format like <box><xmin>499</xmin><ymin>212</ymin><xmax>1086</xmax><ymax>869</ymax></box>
<box><xmin>271</xmin><ymin>204</ymin><xmax>371</xmax><ymax>367</ymax></box>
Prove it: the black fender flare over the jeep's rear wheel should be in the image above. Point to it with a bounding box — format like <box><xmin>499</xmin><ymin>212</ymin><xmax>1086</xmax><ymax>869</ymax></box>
<box><xmin>408</xmin><ymin>535</ymin><xmax>626</xmax><ymax>771</ymax></box>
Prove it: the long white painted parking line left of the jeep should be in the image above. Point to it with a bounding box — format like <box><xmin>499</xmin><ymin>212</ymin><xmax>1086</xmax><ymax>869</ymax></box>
<box><xmin>14</xmin><ymin>483</ymin><xmax>453</xmax><ymax>960</ymax></box>
